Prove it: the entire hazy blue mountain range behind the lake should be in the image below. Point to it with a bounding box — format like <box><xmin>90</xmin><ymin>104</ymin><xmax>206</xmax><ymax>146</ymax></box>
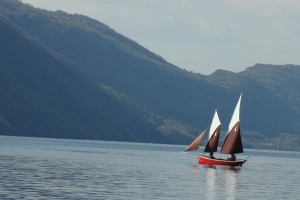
<box><xmin>0</xmin><ymin>0</ymin><xmax>300</xmax><ymax>149</ymax></box>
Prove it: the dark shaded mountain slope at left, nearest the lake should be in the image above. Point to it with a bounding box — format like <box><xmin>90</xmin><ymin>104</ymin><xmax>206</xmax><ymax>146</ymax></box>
<box><xmin>0</xmin><ymin>16</ymin><xmax>176</xmax><ymax>142</ymax></box>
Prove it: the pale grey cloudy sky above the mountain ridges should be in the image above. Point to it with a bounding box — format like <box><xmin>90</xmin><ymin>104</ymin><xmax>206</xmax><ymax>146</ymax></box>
<box><xmin>22</xmin><ymin>0</ymin><xmax>300</xmax><ymax>75</ymax></box>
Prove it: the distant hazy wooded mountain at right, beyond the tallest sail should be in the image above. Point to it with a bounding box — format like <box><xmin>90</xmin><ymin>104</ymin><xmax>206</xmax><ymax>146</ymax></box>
<box><xmin>205</xmin><ymin>64</ymin><xmax>300</xmax><ymax>150</ymax></box>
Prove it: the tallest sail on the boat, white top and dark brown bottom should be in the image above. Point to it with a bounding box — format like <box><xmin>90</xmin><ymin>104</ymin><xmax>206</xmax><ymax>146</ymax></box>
<box><xmin>220</xmin><ymin>94</ymin><xmax>244</xmax><ymax>154</ymax></box>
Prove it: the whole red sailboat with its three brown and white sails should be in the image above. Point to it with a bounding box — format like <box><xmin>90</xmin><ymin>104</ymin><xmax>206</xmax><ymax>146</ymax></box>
<box><xmin>185</xmin><ymin>95</ymin><xmax>247</xmax><ymax>166</ymax></box>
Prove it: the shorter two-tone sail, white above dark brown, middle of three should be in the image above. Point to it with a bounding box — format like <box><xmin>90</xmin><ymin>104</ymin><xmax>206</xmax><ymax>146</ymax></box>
<box><xmin>204</xmin><ymin>111</ymin><xmax>221</xmax><ymax>152</ymax></box>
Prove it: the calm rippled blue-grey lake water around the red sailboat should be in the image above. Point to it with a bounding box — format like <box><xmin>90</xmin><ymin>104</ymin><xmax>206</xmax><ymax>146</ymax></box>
<box><xmin>0</xmin><ymin>136</ymin><xmax>300</xmax><ymax>200</ymax></box>
